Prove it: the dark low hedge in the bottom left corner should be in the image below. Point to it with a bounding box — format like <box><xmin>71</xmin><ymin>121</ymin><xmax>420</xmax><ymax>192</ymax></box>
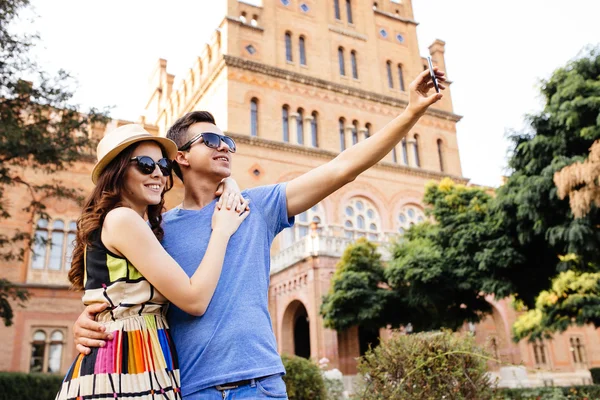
<box><xmin>0</xmin><ymin>372</ymin><xmax>63</xmax><ymax>400</ymax></box>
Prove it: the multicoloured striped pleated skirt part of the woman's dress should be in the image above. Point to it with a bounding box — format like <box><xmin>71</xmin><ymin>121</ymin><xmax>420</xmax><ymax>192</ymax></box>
<box><xmin>56</xmin><ymin>314</ymin><xmax>181</xmax><ymax>400</ymax></box>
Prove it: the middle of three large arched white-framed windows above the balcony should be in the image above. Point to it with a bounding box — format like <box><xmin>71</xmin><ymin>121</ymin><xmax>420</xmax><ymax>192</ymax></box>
<box><xmin>344</xmin><ymin>197</ymin><xmax>381</xmax><ymax>240</ymax></box>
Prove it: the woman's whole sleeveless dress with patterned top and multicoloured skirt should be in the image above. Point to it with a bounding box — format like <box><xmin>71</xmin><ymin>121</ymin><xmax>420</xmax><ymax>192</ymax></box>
<box><xmin>56</xmin><ymin>234</ymin><xmax>181</xmax><ymax>400</ymax></box>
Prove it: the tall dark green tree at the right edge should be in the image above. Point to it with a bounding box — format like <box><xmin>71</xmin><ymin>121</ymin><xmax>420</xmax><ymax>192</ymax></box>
<box><xmin>481</xmin><ymin>48</ymin><xmax>600</xmax><ymax>307</ymax></box>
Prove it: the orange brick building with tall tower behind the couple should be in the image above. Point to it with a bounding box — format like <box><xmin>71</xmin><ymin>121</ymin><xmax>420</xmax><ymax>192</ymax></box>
<box><xmin>0</xmin><ymin>0</ymin><xmax>600</xmax><ymax>384</ymax></box>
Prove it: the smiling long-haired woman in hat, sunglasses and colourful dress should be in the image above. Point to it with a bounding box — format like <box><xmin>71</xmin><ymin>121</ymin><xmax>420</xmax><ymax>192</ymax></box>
<box><xmin>57</xmin><ymin>124</ymin><xmax>249</xmax><ymax>399</ymax></box>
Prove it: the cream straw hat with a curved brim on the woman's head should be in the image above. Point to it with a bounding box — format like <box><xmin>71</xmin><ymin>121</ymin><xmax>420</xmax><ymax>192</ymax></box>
<box><xmin>92</xmin><ymin>124</ymin><xmax>177</xmax><ymax>184</ymax></box>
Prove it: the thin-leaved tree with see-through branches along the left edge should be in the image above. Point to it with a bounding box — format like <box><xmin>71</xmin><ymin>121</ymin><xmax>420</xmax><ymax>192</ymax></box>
<box><xmin>0</xmin><ymin>0</ymin><xmax>106</xmax><ymax>324</ymax></box>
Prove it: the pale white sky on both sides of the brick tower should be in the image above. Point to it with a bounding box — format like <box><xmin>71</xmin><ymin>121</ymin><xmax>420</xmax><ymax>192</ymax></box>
<box><xmin>21</xmin><ymin>0</ymin><xmax>600</xmax><ymax>186</ymax></box>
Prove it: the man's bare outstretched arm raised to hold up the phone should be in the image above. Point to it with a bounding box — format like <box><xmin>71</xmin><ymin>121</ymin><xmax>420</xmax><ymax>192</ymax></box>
<box><xmin>286</xmin><ymin>67</ymin><xmax>445</xmax><ymax>217</ymax></box>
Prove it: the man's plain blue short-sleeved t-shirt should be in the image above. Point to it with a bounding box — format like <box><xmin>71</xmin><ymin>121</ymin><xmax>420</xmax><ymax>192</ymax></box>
<box><xmin>162</xmin><ymin>184</ymin><xmax>294</xmax><ymax>396</ymax></box>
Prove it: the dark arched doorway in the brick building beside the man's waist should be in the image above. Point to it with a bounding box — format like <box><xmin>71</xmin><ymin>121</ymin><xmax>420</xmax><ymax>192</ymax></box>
<box><xmin>282</xmin><ymin>300</ymin><xmax>310</xmax><ymax>358</ymax></box>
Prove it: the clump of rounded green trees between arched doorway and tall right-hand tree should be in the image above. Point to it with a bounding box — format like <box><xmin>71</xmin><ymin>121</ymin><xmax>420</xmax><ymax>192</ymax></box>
<box><xmin>321</xmin><ymin>179</ymin><xmax>510</xmax><ymax>331</ymax></box>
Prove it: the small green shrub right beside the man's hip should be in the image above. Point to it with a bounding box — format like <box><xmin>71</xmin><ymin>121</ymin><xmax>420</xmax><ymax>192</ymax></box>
<box><xmin>281</xmin><ymin>355</ymin><xmax>327</xmax><ymax>400</ymax></box>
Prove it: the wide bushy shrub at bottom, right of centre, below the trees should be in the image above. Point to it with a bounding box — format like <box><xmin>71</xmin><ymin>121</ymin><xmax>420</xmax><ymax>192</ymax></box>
<box><xmin>355</xmin><ymin>332</ymin><xmax>494</xmax><ymax>400</ymax></box>
